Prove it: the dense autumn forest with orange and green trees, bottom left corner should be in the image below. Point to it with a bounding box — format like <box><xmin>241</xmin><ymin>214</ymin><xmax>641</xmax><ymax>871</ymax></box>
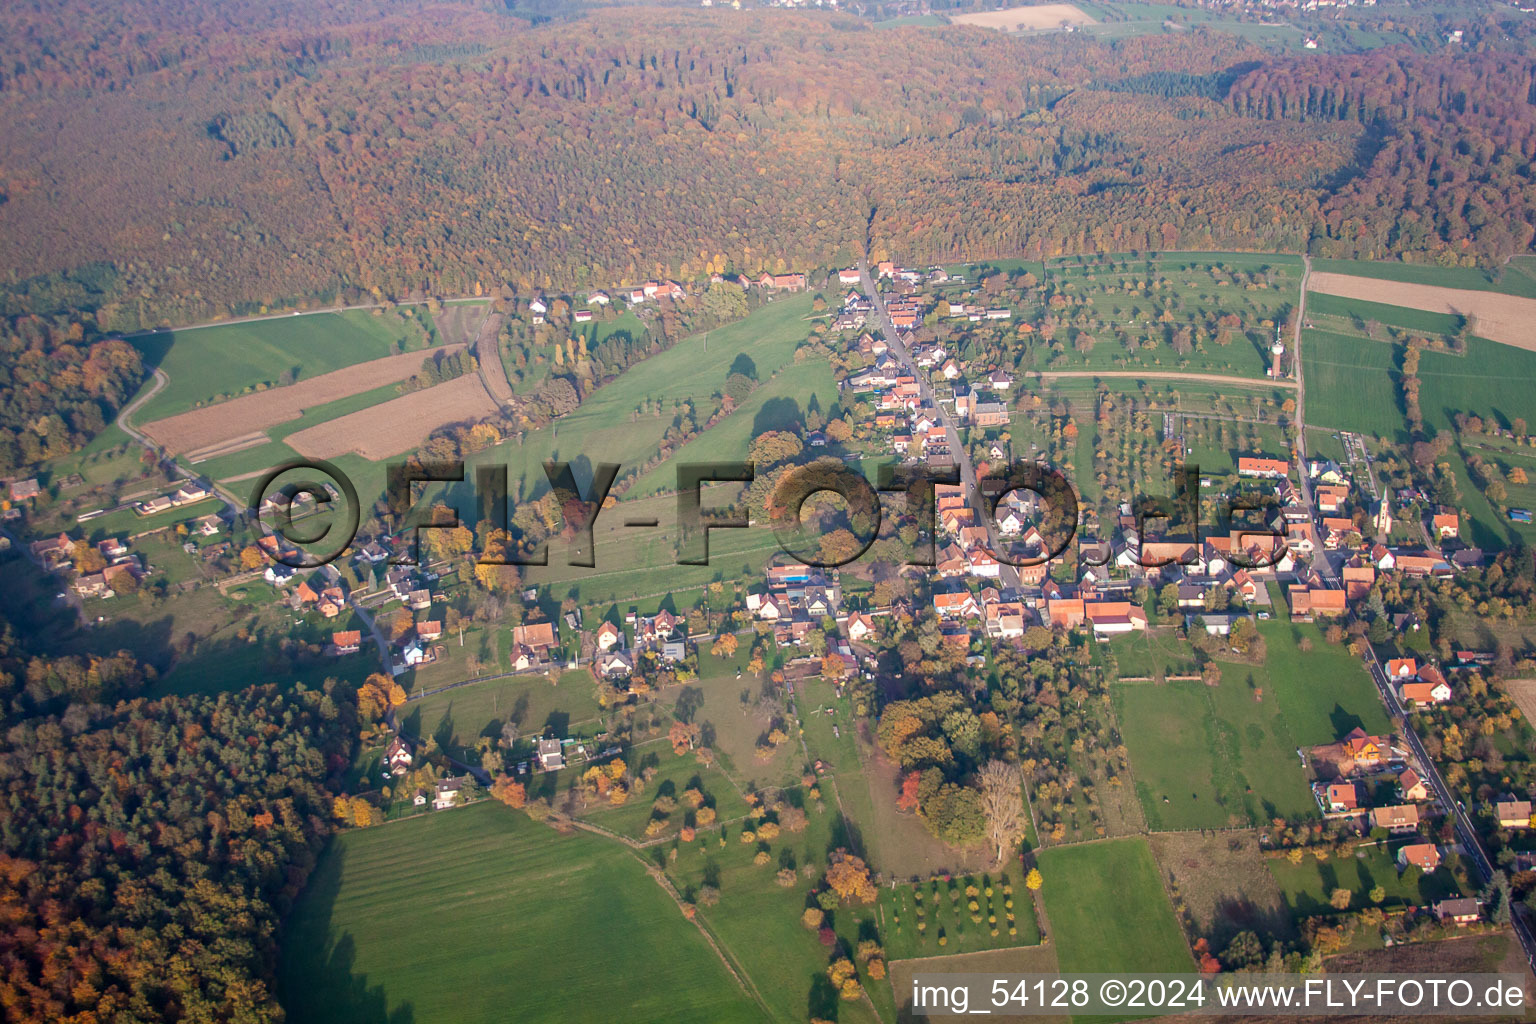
<box><xmin>0</xmin><ymin>601</ymin><xmax>356</xmax><ymax>1024</ymax></box>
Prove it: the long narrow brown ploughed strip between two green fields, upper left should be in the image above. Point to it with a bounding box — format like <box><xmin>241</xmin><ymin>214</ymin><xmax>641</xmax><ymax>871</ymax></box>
<box><xmin>141</xmin><ymin>345</ymin><xmax>462</xmax><ymax>454</ymax></box>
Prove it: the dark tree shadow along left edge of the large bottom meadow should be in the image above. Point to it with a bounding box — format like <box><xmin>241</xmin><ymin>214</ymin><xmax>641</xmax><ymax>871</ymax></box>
<box><xmin>276</xmin><ymin>841</ymin><xmax>416</xmax><ymax>1024</ymax></box>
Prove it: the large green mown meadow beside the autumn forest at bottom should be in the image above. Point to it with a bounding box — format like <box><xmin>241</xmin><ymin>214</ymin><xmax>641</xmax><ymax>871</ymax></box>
<box><xmin>278</xmin><ymin>801</ymin><xmax>771</xmax><ymax>1024</ymax></box>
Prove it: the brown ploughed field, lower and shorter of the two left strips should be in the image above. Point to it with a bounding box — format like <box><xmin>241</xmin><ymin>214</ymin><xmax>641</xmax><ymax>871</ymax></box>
<box><xmin>287</xmin><ymin>373</ymin><xmax>501</xmax><ymax>461</ymax></box>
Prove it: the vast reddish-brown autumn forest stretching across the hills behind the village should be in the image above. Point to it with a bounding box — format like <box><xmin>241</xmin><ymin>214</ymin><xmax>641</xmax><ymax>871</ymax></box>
<box><xmin>0</xmin><ymin>0</ymin><xmax>1536</xmax><ymax>329</ymax></box>
